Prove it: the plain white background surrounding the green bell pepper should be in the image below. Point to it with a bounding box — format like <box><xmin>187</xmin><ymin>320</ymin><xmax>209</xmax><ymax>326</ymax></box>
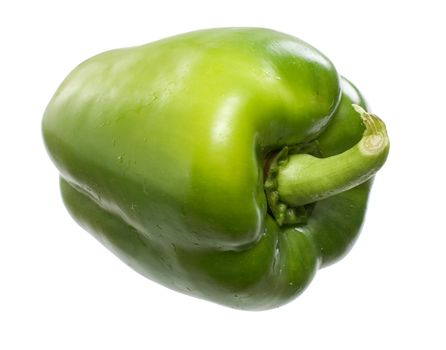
<box><xmin>0</xmin><ymin>0</ymin><xmax>446</xmax><ymax>350</ymax></box>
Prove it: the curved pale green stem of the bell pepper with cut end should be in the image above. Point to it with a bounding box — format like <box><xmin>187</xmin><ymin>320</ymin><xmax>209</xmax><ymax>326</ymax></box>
<box><xmin>265</xmin><ymin>105</ymin><xmax>389</xmax><ymax>225</ymax></box>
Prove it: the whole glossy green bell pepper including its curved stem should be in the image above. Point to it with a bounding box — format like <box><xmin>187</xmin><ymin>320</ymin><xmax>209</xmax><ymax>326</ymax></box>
<box><xmin>43</xmin><ymin>28</ymin><xmax>389</xmax><ymax>310</ymax></box>
